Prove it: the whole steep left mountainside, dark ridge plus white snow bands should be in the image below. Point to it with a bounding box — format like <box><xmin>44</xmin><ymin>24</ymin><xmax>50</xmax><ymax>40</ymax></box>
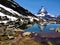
<box><xmin>0</xmin><ymin>0</ymin><xmax>37</xmax><ymax>22</ymax></box>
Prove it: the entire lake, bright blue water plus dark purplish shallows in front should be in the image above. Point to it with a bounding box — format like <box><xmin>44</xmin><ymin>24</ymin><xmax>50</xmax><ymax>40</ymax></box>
<box><xmin>25</xmin><ymin>23</ymin><xmax>60</xmax><ymax>45</ymax></box>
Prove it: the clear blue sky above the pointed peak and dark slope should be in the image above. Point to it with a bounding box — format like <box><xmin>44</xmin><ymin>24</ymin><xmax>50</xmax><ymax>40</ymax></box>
<box><xmin>15</xmin><ymin>0</ymin><xmax>60</xmax><ymax>15</ymax></box>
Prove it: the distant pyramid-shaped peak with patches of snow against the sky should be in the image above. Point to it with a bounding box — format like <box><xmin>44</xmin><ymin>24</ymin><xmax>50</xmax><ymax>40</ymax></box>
<box><xmin>36</xmin><ymin>6</ymin><xmax>55</xmax><ymax>20</ymax></box>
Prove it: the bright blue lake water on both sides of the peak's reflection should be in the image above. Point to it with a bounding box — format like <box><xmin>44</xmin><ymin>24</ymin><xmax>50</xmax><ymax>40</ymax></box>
<box><xmin>25</xmin><ymin>24</ymin><xmax>60</xmax><ymax>33</ymax></box>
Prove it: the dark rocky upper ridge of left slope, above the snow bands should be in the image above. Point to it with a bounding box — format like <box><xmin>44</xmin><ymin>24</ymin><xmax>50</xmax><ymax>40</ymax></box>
<box><xmin>0</xmin><ymin>0</ymin><xmax>36</xmax><ymax>17</ymax></box>
